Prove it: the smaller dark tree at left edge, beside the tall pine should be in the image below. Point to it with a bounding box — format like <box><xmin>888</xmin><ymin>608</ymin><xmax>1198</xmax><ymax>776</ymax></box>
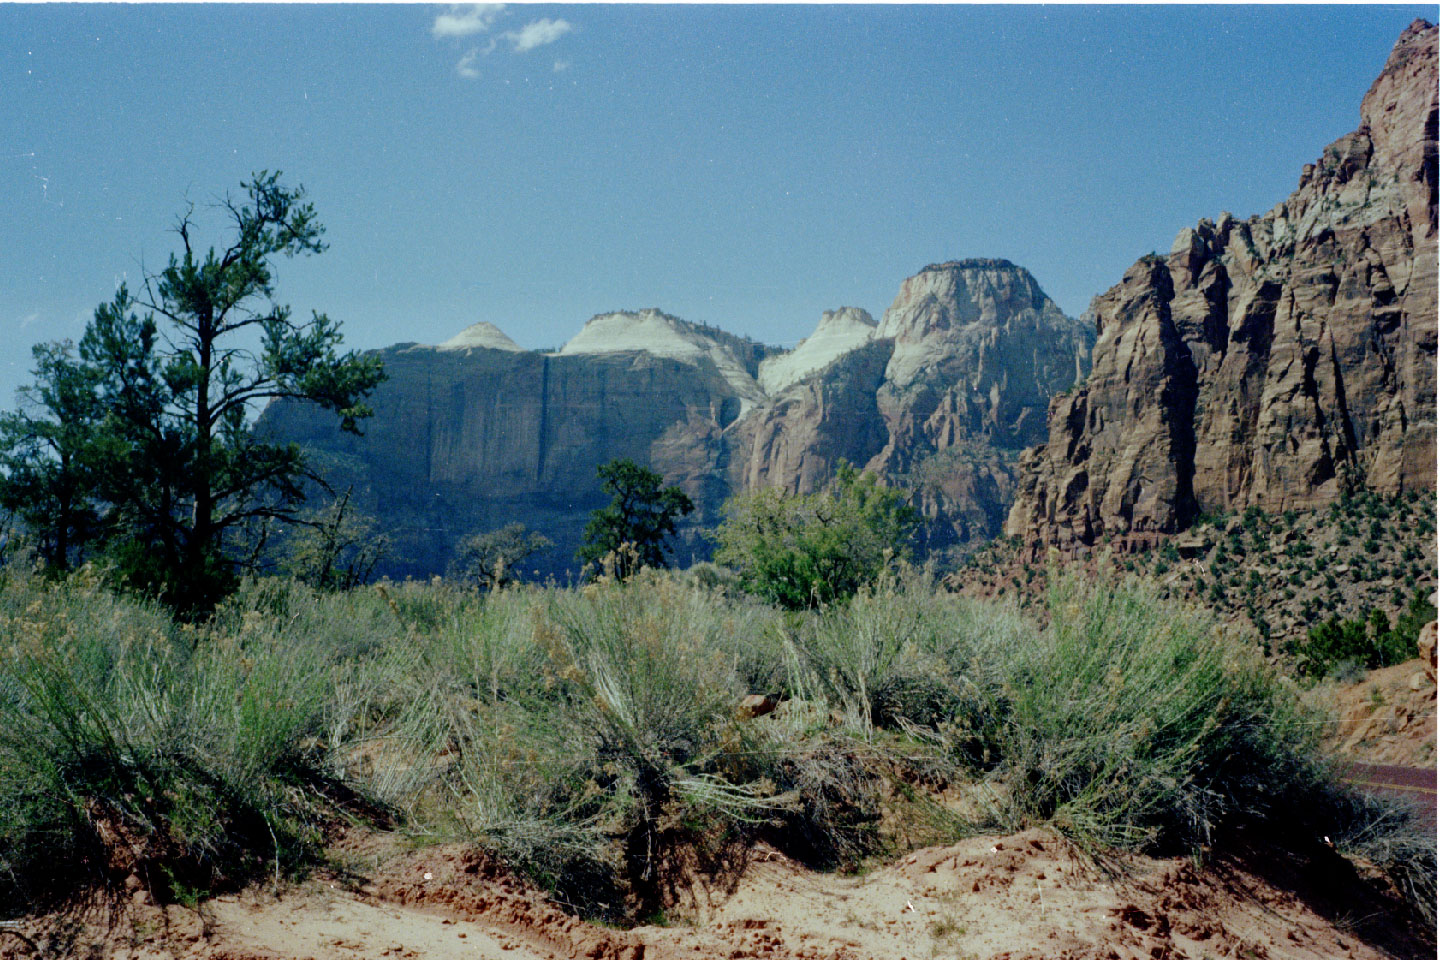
<box><xmin>0</xmin><ymin>341</ymin><xmax>101</xmax><ymax>571</ymax></box>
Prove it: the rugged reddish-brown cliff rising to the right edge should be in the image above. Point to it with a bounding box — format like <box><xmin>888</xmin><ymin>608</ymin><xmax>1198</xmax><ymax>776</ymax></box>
<box><xmin>1005</xmin><ymin>20</ymin><xmax>1437</xmax><ymax>553</ymax></box>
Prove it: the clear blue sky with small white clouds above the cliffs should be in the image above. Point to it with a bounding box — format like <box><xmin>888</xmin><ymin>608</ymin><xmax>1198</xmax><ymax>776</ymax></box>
<box><xmin>0</xmin><ymin>4</ymin><xmax>1434</xmax><ymax>406</ymax></box>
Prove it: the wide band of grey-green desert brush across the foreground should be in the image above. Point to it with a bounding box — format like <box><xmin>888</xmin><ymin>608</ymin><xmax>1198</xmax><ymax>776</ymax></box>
<box><xmin>0</xmin><ymin>555</ymin><xmax>1434</xmax><ymax>923</ymax></box>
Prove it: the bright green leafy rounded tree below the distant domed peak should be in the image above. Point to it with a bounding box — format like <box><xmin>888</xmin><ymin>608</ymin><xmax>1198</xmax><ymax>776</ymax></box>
<box><xmin>714</xmin><ymin>461</ymin><xmax>920</xmax><ymax>610</ymax></box>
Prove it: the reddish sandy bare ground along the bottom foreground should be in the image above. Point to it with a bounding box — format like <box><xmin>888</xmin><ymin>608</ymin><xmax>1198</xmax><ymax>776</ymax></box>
<box><xmin>8</xmin><ymin>830</ymin><xmax>1436</xmax><ymax>960</ymax></box>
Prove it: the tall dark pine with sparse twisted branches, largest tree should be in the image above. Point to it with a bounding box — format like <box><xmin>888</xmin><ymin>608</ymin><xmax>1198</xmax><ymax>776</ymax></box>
<box><xmin>7</xmin><ymin>173</ymin><xmax>384</xmax><ymax>613</ymax></box>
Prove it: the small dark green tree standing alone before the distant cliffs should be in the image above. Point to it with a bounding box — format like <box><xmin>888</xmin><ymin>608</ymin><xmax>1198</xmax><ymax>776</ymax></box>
<box><xmin>576</xmin><ymin>459</ymin><xmax>696</xmax><ymax>580</ymax></box>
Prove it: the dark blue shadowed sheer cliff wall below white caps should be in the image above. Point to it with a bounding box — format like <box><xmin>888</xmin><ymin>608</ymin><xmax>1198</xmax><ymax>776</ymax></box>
<box><xmin>258</xmin><ymin>339</ymin><xmax>740</xmax><ymax>576</ymax></box>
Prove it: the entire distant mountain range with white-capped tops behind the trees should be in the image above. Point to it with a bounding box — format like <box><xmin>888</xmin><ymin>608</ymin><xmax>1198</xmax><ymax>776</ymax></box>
<box><xmin>258</xmin><ymin>261</ymin><xmax>1092</xmax><ymax>576</ymax></box>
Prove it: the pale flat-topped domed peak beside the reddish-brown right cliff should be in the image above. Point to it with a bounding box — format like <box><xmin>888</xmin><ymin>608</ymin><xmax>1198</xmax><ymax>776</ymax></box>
<box><xmin>737</xmin><ymin>259</ymin><xmax>1093</xmax><ymax>548</ymax></box>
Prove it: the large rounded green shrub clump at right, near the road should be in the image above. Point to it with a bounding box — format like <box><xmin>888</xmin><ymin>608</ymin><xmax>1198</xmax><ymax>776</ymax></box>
<box><xmin>989</xmin><ymin>577</ymin><xmax>1320</xmax><ymax>851</ymax></box>
